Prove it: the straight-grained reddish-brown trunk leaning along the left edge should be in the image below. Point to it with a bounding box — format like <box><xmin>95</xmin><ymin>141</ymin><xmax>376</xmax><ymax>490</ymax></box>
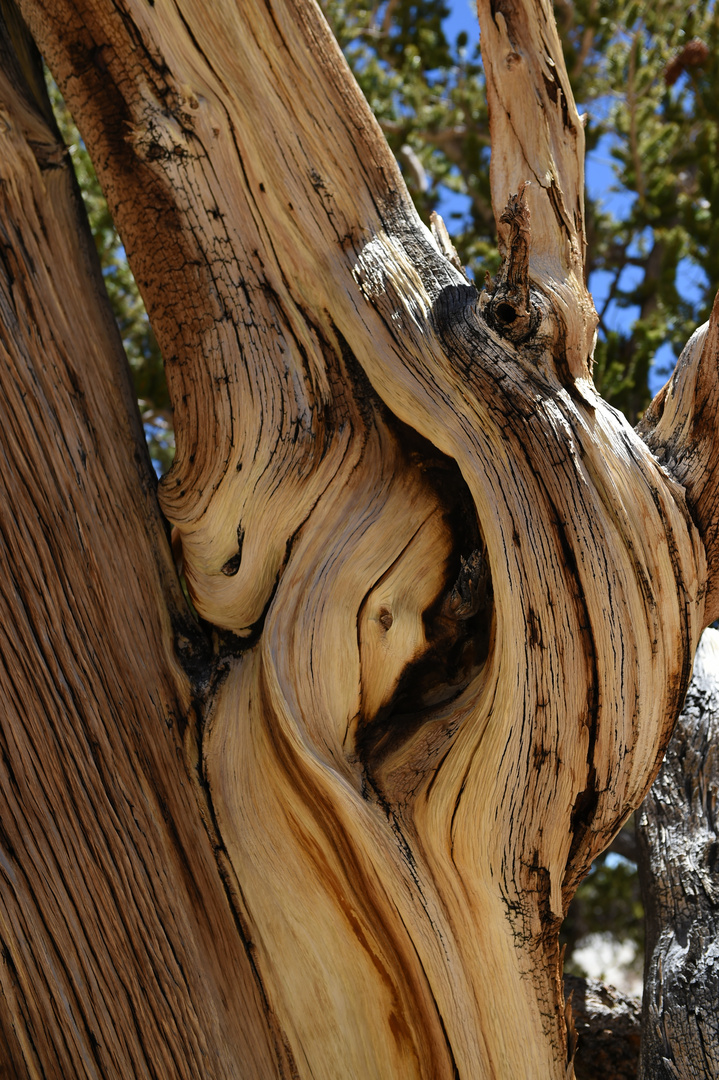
<box><xmin>0</xmin><ymin>9</ymin><xmax>288</xmax><ymax>1080</ymax></box>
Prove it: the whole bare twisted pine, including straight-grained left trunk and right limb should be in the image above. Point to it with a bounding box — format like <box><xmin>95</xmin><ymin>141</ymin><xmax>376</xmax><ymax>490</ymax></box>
<box><xmin>0</xmin><ymin>0</ymin><xmax>719</xmax><ymax>1080</ymax></box>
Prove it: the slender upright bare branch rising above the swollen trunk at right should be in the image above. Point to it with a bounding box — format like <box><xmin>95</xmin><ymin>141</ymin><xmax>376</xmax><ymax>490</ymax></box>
<box><xmin>477</xmin><ymin>0</ymin><xmax>597</xmax><ymax>384</ymax></box>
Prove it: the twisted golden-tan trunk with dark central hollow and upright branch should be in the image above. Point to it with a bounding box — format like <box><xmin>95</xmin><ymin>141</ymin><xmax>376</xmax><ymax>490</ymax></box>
<box><xmin>1</xmin><ymin>0</ymin><xmax>708</xmax><ymax>1080</ymax></box>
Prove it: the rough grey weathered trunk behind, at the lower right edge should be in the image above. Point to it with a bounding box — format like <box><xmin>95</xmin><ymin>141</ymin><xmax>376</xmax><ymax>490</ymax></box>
<box><xmin>638</xmin><ymin>630</ymin><xmax>719</xmax><ymax>1080</ymax></box>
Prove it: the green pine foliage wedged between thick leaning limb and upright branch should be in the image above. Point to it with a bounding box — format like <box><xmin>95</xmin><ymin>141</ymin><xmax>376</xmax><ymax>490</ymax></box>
<box><xmin>321</xmin><ymin>0</ymin><xmax>500</xmax><ymax>281</ymax></box>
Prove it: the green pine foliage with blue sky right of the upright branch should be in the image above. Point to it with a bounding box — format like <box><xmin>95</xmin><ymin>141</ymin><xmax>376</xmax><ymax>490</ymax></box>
<box><xmin>556</xmin><ymin>0</ymin><xmax>719</xmax><ymax>421</ymax></box>
